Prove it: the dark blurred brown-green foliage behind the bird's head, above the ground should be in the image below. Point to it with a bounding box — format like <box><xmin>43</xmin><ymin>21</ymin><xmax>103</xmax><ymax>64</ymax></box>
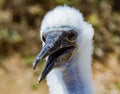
<box><xmin>0</xmin><ymin>0</ymin><xmax>120</xmax><ymax>60</ymax></box>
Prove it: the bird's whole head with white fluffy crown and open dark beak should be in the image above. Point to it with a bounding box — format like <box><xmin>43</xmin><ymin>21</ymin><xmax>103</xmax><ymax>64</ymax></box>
<box><xmin>33</xmin><ymin>6</ymin><xmax>93</xmax><ymax>82</ymax></box>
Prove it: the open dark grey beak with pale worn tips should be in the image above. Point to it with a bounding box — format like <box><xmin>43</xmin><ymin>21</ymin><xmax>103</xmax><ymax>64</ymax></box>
<box><xmin>33</xmin><ymin>31</ymin><xmax>73</xmax><ymax>83</ymax></box>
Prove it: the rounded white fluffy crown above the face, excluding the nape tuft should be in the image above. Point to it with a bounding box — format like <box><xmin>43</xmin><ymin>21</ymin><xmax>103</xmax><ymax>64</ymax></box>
<box><xmin>41</xmin><ymin>5</ymin><xmax>83</xmax><ymax>32</ymax></box>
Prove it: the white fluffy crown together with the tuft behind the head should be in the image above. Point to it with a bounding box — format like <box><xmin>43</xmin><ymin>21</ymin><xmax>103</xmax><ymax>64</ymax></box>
<box><xmin>40</xmin><ymin>5</ymin><xmax>94</xmax><ymax>40</ymax></box>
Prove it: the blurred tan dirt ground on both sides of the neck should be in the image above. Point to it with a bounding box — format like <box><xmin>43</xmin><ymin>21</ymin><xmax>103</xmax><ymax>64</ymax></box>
<box><xmin>0</xmin><ymin>54</ymin><xmax>120</xmax><ymax>94</ymax></box>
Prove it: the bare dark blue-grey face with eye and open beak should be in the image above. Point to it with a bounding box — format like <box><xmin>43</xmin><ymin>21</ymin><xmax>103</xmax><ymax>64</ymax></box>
<box><xmin>33</xmin><ymin>30</ymin><xmax>77</xmax><ymax>82</ymax></box>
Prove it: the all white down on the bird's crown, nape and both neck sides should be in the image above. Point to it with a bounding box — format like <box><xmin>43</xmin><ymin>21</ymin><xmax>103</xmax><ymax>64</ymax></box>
<box><xmin>40</xmin><ymin>5</ymin><xmax>94</xmax><ymax>94</ymax></box>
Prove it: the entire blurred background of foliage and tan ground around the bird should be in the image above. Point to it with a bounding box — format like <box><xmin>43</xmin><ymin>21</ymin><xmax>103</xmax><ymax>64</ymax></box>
<box><xmin>0</xmin><ymin>0</ymin><xmax>120</xmax><ymax>94</ymax></box>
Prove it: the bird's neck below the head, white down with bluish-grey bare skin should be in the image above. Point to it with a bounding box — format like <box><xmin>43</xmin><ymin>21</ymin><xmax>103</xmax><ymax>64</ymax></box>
<box><xmin>47</xmin><ymin>43</ymin><xmax>94</xmax><ymax>94</ymax></box>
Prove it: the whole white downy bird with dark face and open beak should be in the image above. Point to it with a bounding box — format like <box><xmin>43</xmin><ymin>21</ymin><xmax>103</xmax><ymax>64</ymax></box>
<box><xmin>32</xmin><ymin>5</ymin><xmax>95</xmax><ymax>94</ymax></box>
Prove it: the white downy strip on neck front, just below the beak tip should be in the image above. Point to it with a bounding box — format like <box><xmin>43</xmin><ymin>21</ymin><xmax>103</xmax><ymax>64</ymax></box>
<box><xmin>46</xmin><ymin>69</ymin><xmax>68</xmax><ymax>94</ymax></box>
